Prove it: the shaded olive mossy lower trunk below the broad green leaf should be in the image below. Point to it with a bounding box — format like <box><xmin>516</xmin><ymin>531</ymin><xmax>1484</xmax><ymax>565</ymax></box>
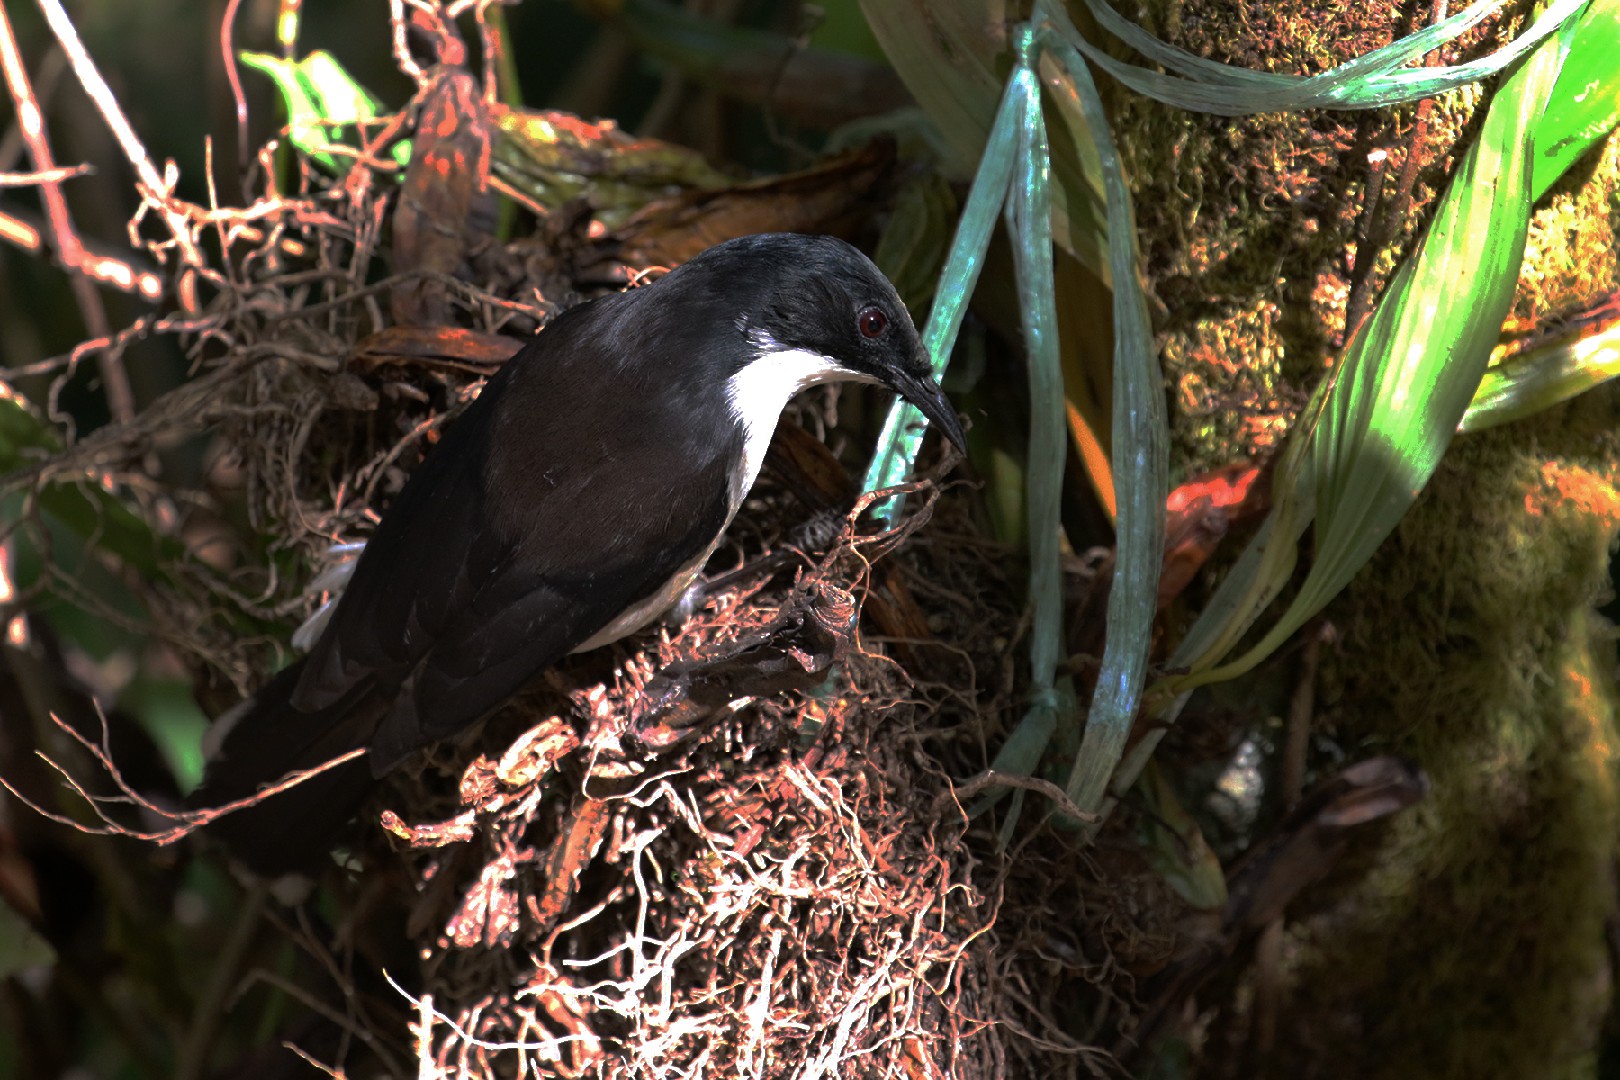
<box><xmin>1270</xmin><ymin>390</ymin><xmax>1620</xmax><ymax>1080</ymax></box>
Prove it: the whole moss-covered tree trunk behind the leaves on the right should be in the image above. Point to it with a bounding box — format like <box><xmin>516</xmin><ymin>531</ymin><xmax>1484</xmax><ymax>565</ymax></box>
<box><xmin>1110</xmin><ymin>0</ymin><xmax>1620</xmax><ymax>1080</ymax></box>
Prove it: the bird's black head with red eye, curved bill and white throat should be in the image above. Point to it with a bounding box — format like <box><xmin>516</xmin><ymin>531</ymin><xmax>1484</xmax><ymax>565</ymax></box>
<box><xmin>671</xmin><ymin>233</ymin><xmax>964</xmax><ymax>447</ymax></box>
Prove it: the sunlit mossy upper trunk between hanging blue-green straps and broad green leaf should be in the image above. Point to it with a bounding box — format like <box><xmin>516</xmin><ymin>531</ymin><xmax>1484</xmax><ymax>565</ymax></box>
<box><xmin>1110</xmin><ymin>0</ymin><xmax>1524</xmax><ymax>473</ymax></box>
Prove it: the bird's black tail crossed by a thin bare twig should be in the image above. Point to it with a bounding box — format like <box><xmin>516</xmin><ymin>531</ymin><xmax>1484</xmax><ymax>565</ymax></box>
<box><xmin>188</xmin><ymin>661</ymin><xmax>381</xmax><ymax>876</ymax></box>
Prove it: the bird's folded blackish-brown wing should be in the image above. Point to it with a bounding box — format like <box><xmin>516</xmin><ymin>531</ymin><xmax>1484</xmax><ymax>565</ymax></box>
<box><xmin>292</xmin><ymin>327</ymin><xmax>734</xmax><ymax>774</ymax></box>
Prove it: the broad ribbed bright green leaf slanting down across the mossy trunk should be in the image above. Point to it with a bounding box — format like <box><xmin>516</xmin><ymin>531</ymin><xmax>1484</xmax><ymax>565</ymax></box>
<box><xmin>1166</xmin><ymin>8</ymin><xmax>1568</xmax><ymax>690</ymax></box>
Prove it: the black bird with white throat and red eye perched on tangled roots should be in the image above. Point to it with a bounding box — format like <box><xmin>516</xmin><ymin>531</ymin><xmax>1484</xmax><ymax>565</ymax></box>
<box><xmin>190</xmin><ymin>233</ymin><xmax>966</xmax><ymax>876</ymax></box>
